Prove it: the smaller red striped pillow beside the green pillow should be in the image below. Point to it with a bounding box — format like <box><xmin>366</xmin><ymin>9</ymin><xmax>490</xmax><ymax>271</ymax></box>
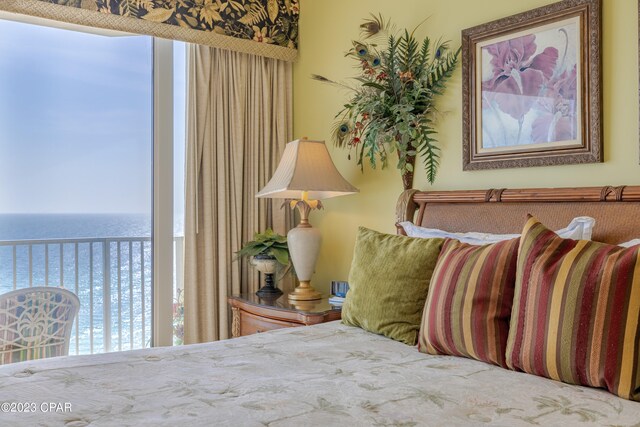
<box><xmin>418</xmin><ymin>239</ymin><xmax>519</xmax><ymax>367</ymax></box>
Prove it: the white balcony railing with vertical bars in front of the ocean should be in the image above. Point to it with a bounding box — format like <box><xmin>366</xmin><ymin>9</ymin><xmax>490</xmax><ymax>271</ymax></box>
<box><xmin>0</xmin><ymin>237</ymin><xmax>184</xmax><ymax>354</ymax></box>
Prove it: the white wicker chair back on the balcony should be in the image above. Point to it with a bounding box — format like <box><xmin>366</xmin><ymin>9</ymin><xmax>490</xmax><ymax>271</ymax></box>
<box><xmin>0</xmin><ymin>287</ymin><xmax>80</xmax><ymax>365</ymax></box>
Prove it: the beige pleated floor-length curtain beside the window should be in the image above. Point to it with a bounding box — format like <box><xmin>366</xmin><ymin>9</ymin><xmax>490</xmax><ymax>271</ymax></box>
<box><xmin>184</xmin><ymin>45</ymin><xmax>292</xmax><ymax>344</ymax></box>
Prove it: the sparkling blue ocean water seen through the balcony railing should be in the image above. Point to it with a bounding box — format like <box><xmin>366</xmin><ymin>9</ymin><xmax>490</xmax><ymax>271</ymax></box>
<box><xmin>0</xmin><ymin>214</ymin><xmax>152</xmax><ymax>354</ymax></box>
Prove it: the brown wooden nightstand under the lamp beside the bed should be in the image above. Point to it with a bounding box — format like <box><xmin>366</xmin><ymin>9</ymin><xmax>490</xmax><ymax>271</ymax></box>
<box><xmin>229</xmin><ymin>294</ymin><xmax>341</xmax><ymax>338</ymax></box>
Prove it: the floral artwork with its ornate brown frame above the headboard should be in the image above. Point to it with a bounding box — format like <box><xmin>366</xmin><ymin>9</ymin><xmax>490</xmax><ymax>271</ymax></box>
<box><xmin>462</xmin><ymin>0</ymin><xmax>603</xmax><ymax>170</ymax></box>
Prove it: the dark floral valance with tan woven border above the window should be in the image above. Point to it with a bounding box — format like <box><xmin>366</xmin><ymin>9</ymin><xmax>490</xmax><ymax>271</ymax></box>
<box><xmin>0</xmin><ymin>0</ymin><xmax>300</xmax><ymax>61</ymax></box>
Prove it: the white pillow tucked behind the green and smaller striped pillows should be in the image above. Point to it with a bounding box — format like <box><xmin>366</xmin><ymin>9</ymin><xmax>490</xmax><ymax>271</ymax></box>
<box><xmin>400</xmin><ymin>216</ymin><xmax>596</xmax><ymax>245</ymax></box>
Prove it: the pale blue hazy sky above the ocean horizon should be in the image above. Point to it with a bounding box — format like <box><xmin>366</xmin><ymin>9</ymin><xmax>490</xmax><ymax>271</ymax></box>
<box><xmin>0</xmin><ymin>20</ymin><xmax>185</xmax><ymax>213</ymax></box>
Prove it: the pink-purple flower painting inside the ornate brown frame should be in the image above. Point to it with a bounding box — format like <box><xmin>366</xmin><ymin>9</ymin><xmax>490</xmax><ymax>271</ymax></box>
<box><xmin>481</xmin><ymin>25</ymin><xmax>579</xmax><ymax>148</ymax></box>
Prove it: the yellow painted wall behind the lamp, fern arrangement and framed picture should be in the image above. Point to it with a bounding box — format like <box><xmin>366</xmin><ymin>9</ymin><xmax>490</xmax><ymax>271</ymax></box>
<box><xmin>294</xmin><ymin>0</ymin><xmax>640</xmax><ymax>292</ymax></box>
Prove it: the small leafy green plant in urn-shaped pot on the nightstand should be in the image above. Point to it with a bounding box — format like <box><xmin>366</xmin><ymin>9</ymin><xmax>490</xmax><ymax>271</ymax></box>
<box><xmin>236</xmin><ymin>228</ymin><xmax>289</xmax><ymax>298</ymax></box>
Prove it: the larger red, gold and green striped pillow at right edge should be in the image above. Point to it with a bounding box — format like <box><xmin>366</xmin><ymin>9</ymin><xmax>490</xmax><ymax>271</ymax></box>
<box><xmin>506</xmin><ymin>217</ymin><xmax>640</xmax><ymax>401</ymax></box>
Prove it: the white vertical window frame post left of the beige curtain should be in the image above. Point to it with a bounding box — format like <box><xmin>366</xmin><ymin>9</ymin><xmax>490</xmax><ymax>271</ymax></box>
<box><xmin>151</xmin><ymin>38</ymin><xmax>173</xmax><ymax>347</ymax></box>
